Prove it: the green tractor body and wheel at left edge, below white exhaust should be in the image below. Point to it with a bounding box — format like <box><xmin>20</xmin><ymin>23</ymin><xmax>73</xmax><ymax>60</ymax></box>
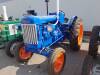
<box><xmin>0</xmin><ymin>21</ymin><xmax>22</xmax><ymax>57</ymax></box>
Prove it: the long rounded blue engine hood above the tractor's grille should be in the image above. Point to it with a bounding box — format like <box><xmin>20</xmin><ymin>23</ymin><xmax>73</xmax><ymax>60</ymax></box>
<box><xmin>21</xmin><ymin>15</ymin><xmax>57</xmax><ymax>24</ymax></box>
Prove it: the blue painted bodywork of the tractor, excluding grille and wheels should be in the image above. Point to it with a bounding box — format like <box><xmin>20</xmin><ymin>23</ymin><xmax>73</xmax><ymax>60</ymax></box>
<box><xmin>21</xmin><ymin>12</ymin><xmax>77</xmax><ymax>57</ymax></box>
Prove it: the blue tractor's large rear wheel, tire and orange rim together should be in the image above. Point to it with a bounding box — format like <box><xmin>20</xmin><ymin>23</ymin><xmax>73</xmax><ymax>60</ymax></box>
<box><xmin>70</xmin><ymin>18</ymin><xmax>83</xmax><ymax>51</ymax></box>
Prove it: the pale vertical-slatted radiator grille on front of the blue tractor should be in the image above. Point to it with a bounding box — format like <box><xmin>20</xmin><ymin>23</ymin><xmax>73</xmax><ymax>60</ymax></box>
<box><xmin>22</xmin><ymin>24</ymin><xmax>38</xmax><ymax>44</ymax></box>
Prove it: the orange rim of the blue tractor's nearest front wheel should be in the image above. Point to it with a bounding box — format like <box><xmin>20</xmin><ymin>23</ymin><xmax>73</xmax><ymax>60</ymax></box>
<box><xmin>54</xmin><ymin>52</ymin><xmax>64</xmax><ymax>73</ymax></box>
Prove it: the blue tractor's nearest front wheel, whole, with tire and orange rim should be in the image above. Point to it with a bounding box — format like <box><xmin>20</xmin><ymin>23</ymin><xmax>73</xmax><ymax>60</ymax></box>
<box><xmin>48</xmin><ymin>47</ymin><xmax>65</xmax><ymax>75</ymax></box>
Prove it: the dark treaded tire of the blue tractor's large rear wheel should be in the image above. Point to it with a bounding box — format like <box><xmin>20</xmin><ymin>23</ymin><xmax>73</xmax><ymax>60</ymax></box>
<box><xmin>70</xmin><ymin>18</ymin><xmax>82</xmax><ymax>51</ymax></box>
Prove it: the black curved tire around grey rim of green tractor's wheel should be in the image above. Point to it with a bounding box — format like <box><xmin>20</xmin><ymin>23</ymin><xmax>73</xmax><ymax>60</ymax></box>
<box><xmin>5</xmin><ymin>40</ymin><xmax>17</xmax><ymax>57</ymax></box>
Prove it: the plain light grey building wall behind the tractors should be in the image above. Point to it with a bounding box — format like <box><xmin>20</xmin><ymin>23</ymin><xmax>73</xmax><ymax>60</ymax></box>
<box><xmin>0</xmin><ymin>0</ymin><xmax>100</xmax><ymax>31</ymax></box>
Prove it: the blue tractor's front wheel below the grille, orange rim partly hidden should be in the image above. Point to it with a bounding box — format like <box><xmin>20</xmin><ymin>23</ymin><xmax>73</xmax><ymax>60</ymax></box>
<box><xmin>15</xmin><ymin>43</ymin><xmax>32</xmax><ymax>63</ymax></box>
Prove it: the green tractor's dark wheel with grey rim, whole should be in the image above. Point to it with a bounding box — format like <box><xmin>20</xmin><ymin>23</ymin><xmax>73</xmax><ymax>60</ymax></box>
<box><xmin>5</xmin><ymin>40</ymin><xmax>18</xmax><ymax>57</ymax></box>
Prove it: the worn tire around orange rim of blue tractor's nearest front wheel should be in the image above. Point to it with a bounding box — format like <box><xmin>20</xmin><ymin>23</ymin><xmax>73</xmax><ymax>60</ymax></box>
<box><xmin>48</xmin><ymin>47</ymin><xmax>66</xmax><ymax>75</ymax></box>
